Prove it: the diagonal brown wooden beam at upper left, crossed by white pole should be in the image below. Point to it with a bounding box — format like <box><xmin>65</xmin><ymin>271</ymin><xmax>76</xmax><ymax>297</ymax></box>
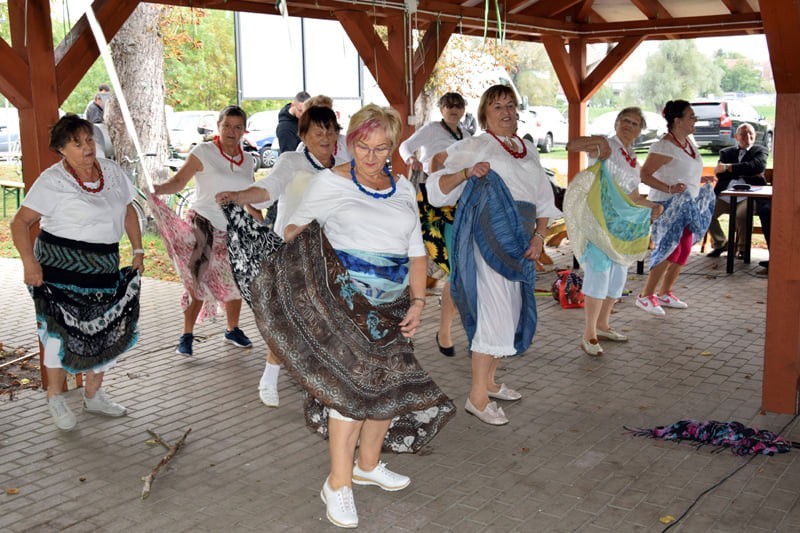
<box><xmin>55</xmin><ymin>0</ymin><xmax>139</xmax><ymax>104</ymax></box>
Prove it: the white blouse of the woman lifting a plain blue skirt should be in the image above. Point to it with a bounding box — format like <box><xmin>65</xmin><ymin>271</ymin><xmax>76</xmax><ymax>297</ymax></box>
<box><xmin>427</xmin><ymin>133</ymin><xmax>561</xmax><ymax>218</ymax></box>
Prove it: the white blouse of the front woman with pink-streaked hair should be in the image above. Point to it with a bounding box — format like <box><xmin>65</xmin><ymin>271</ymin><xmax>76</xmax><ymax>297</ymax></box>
<box><xmin>288</xmin><ymin>170</ymin><xmax>426</xmax><ymax>257</ymax></box>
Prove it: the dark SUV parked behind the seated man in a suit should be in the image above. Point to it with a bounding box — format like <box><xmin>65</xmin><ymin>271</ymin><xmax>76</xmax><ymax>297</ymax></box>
<box><xmin>691</xmin><ymin>100</ymin><xmax>775</xmax><ymax>153</ymax></box>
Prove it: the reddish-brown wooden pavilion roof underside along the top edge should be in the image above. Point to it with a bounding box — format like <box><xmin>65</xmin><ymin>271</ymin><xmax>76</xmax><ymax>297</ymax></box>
<box><xmin>155</xmin><ymin>0</ymin><xmax>764</xmax><ymax>42</ymax></box>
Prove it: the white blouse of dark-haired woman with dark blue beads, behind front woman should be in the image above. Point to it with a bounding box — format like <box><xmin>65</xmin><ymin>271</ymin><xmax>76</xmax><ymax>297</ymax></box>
<box><xmin>253</xmin><ymin>152</ymin><xmax>346</xmax><ymax>236</ymax></box>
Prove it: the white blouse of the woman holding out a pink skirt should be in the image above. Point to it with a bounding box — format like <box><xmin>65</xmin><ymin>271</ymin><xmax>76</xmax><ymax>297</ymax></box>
<box><xmin>190</xmin><ymin>142</ymin><xmax>253</xmax><ymax>231</ymax></box>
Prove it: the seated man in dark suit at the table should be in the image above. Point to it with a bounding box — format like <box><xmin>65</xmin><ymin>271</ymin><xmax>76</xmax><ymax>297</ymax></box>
<box><xmin>708</xmin><ymin>124</ymin><xmax>771</xmax><ymax>266</ymax></box>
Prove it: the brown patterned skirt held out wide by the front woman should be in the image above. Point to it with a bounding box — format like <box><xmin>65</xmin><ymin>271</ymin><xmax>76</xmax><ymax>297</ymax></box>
<box><xmin>223</xmin><ymin>205</ymin><xmax>455</xmax><ymax>452</ymax></box>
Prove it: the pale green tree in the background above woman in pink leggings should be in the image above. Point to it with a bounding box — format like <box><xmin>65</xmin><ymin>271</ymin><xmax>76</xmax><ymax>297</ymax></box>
<box><xmin>634</xmin><ymin>40</ymin><xmax>722</xmax><ymax>111</ymax></box>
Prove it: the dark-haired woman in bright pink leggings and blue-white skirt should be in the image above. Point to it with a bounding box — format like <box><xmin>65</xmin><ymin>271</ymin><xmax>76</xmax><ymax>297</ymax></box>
<box><xmin>636</xmin><ymin>100</ymin><xmax>716</xmax><ymax>316</ymax></box>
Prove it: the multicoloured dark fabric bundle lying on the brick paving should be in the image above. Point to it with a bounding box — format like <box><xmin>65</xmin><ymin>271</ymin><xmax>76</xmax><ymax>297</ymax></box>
<box><xmin>626</xmin><ymin>420</ymin><xmax>792</xmax><ymax>455</ymax></box>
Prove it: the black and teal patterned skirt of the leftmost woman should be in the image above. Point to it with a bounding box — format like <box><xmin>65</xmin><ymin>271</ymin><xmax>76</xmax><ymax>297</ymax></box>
<box><xmin>29</xmin><ymin>231</ymin><xmax>141</xmax><ymax>373</ymax></box>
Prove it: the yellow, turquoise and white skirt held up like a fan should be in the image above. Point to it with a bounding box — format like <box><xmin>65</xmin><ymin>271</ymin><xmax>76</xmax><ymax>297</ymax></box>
<box><xmin>564</xmin><ymin>161</ymin><xmax>650</xmax><ymax>272</ymax></box>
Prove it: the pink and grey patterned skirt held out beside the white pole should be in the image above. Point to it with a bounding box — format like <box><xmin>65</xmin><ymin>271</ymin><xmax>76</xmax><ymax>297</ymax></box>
<box><xmin>147</xmin><ymin>194</ymin><xmax>242</xmax><ymax>322</ymax></box>
